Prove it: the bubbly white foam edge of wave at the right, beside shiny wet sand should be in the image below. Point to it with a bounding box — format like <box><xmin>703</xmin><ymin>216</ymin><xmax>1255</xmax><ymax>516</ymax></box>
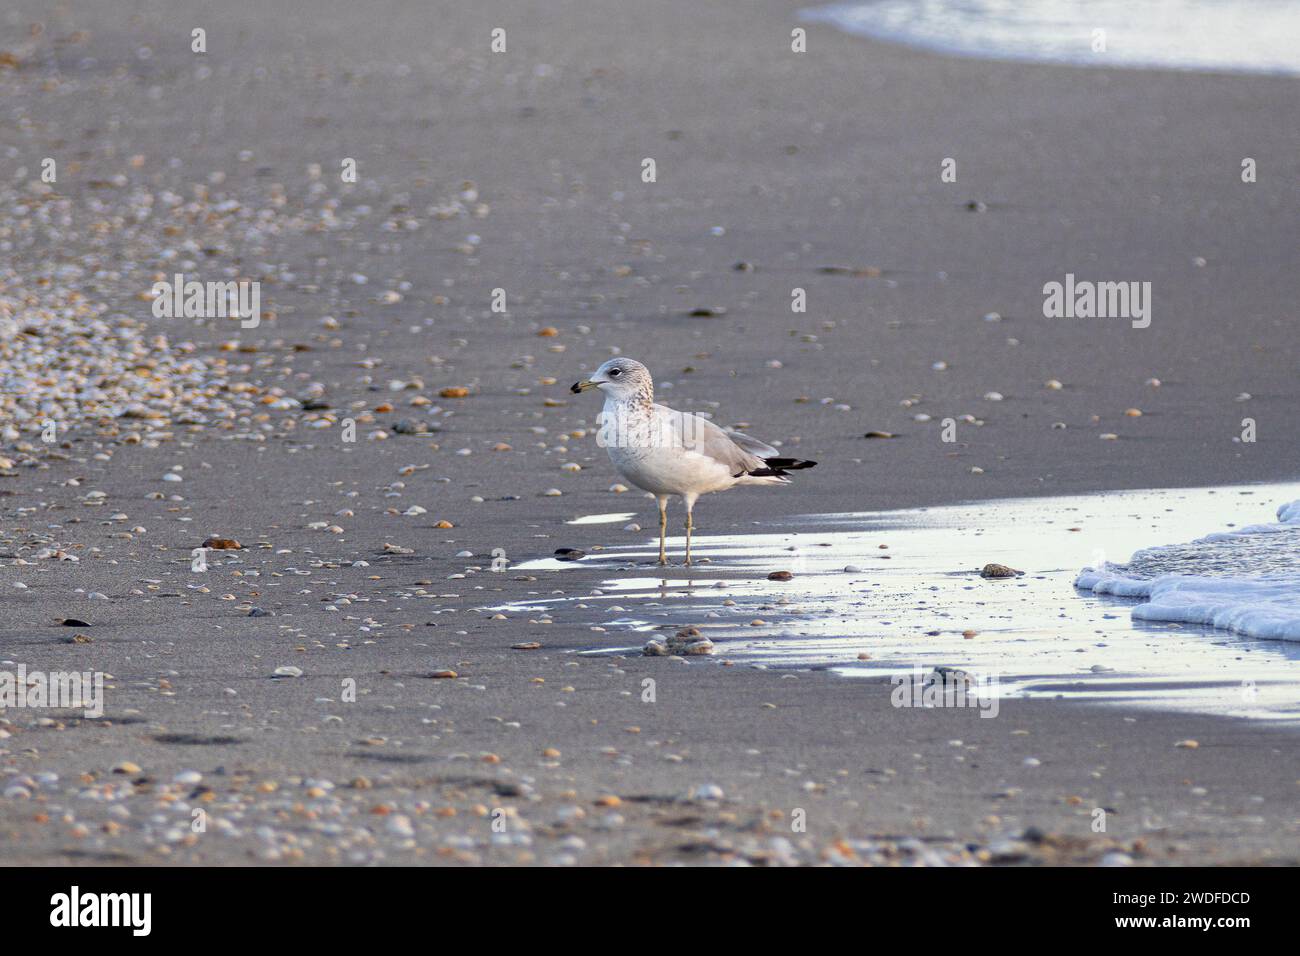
<box><xmin>1075</xmin><ymin>501</ymin><xmax>1300</xmax><ymax>641</ymax></box>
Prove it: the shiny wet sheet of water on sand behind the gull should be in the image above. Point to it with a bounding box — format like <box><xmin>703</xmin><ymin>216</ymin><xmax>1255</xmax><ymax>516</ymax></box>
<box><xmin>497</xmin><ymin>485</ymin><xmax>1300</xmax><ymax>722</ymax></box>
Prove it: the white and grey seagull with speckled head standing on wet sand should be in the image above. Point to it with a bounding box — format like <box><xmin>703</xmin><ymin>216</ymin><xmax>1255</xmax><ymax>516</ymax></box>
<box><xmin>571</xmin><ymin>358</ymin><xmax>816</xmax><ymax>564</ymax></box>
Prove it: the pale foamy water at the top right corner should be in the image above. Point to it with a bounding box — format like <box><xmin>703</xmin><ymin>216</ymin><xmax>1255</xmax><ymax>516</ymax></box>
<box><xmin>801</xmin><ymin>0</ymin><xmax>1300</xmax><ymax>75</ymax></box>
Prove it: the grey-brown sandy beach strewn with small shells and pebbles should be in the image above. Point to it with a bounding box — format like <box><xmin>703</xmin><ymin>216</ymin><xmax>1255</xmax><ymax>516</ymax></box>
<box><xmin>0</xmin><ymin>0</ymin><xmax>1300</xmax><ymax>865</ymax></box>
